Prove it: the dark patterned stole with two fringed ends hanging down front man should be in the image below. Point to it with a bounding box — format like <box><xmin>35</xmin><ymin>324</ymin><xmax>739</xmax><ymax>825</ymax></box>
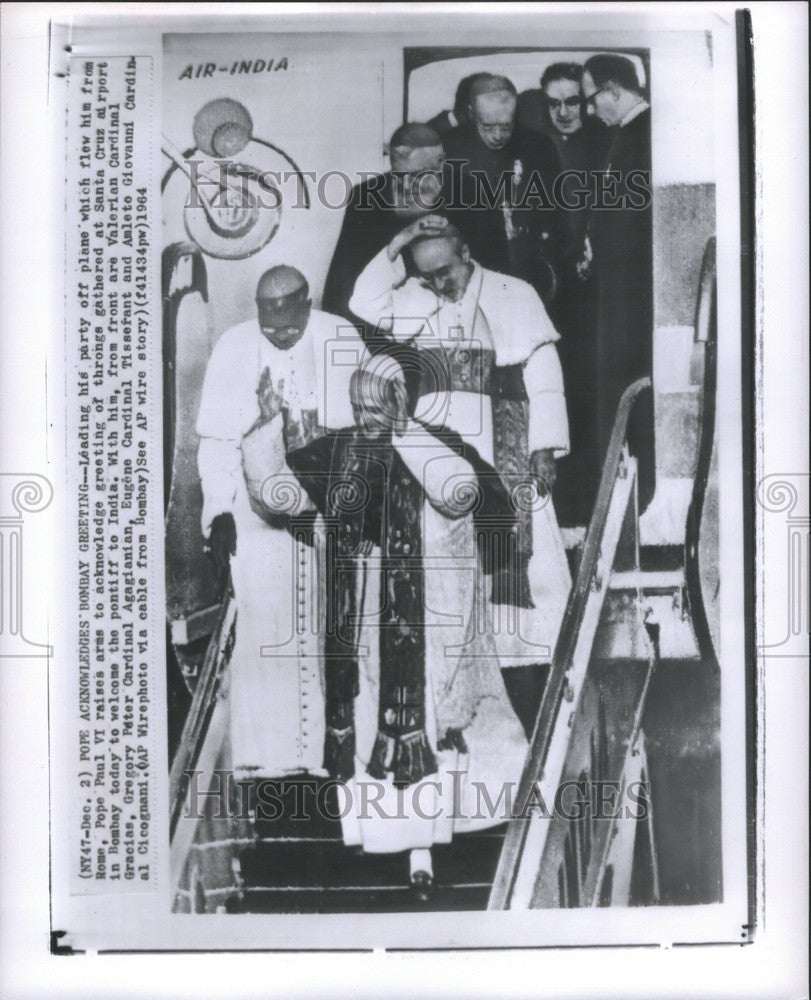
<box><xmin>314</xmin><ymin>434</ymin><xmax>436</xmax><ymax>787</ymax></box>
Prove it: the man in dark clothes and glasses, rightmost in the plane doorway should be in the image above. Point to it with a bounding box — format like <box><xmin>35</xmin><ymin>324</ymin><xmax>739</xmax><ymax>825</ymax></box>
<box><xmin>582</xmin><ymin>55</ymin><xmax>656</xmax><ymax>510</ymax></box>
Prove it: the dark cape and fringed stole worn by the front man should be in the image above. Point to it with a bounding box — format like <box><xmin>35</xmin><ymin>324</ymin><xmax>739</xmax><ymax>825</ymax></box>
<box><xmin>287</xmin><ymin>428</ymin><xmax>521</xmax><ymax>787</ymax></box>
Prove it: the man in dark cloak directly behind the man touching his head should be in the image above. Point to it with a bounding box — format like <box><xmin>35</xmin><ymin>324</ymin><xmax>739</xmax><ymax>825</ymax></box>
<box><xmin>322</xmin><ymin>123</ymin><xmax>445</xmax><ymax>326</ymax></box>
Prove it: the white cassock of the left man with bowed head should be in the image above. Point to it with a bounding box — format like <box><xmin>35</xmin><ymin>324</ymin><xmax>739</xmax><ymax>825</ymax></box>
<box><xmin>197</xmin><ymin>309</ymin><xmax>364</xmax><ymax>776</ymax></box>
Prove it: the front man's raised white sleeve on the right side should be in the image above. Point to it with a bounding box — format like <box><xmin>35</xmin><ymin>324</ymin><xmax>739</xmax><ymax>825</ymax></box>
<box><xmin>392</xmin><ymin>420</ymin><xmax>478</xmax><ymax>518</ymax></box>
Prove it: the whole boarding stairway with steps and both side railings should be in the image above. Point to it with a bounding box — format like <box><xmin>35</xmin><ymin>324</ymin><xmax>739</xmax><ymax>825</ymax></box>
<box><xmin>170</xmin><ymin>241</ymin><xmax>717</xmax><ymax>913</ymax></box>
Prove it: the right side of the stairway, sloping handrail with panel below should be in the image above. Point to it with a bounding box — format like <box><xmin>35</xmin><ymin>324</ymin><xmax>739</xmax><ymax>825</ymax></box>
<box><xmin>488</xmin><ymin>378</ymin><xmax>658</xmax><ymax>910</ymax></box>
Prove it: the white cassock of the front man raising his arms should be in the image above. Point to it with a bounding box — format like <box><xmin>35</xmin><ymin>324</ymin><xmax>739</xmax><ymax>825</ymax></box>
<box><xmin>258</xmin><ymin>417</ymin><xmax>527</xmax><ymax>853</ymax></box>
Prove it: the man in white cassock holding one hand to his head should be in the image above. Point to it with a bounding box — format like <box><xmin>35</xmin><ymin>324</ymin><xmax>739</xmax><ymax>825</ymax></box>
<box><xmin>350</xmin><ymin>215</ymin><xmax>571</xmax><ymax>704</ymax></box>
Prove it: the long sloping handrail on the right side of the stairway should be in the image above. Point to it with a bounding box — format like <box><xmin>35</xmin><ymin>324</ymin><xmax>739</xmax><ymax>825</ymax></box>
<box><xmin>488</xmin><ymin>377</ymin><xmax>652</xmax><ymax>910</ymax></box>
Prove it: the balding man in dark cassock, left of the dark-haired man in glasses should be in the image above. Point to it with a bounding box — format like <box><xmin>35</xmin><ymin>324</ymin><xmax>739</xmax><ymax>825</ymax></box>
<box><xmin>443</xmin><ymin>73</ymin><xmax>567</xmax><ymax>303</ymax></box>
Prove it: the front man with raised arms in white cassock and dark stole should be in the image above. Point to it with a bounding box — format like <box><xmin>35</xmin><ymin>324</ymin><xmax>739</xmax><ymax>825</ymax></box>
<box><xmin>254</xmin><ymin>355</ymin><xmax>527</xmax><ymax>900</ymax></box>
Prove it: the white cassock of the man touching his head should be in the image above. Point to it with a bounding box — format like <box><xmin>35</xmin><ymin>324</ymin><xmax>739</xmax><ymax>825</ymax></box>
<box><xmin>349</xmin><ymin>249</ymin><xmax>571</xmax><ymax>667</ymax></box>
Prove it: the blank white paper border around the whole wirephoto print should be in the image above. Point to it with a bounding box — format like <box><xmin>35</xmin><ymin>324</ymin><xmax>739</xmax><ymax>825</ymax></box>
<box><xmin>0</xmin><ymin>3</ymin><xmax>808</xmax><ymax>997</ymax></box>
